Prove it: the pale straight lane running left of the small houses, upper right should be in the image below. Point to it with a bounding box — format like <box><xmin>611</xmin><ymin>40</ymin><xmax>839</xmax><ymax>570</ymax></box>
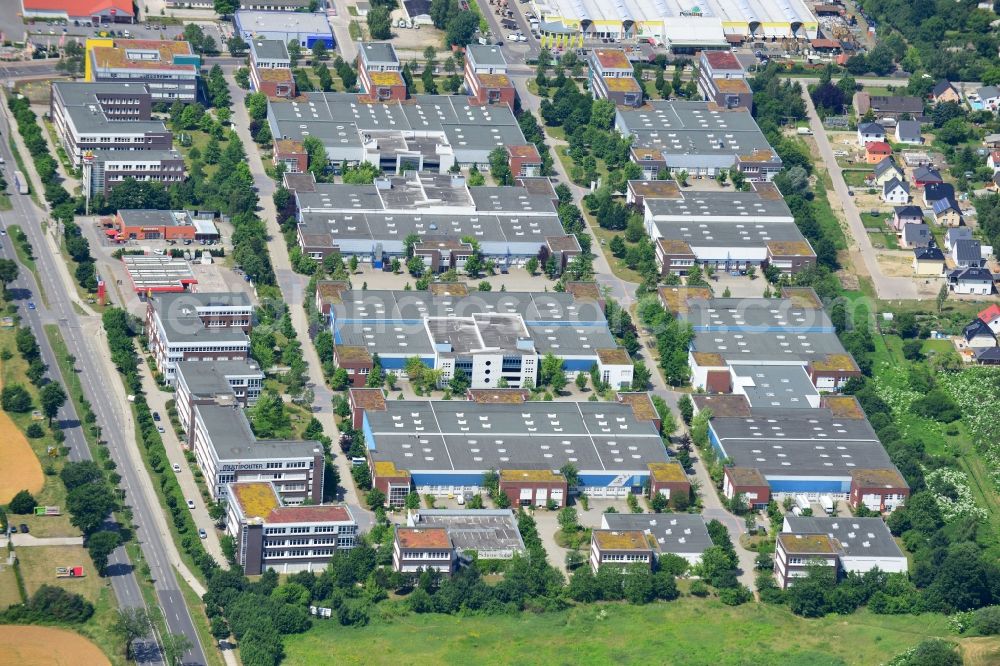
<box><xmin>802</xmin><ymin>87</ymin><xmax>920</xmax><ymax>300</ymax></box>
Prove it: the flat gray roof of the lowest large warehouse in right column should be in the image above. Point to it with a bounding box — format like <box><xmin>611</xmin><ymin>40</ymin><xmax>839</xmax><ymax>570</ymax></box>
<box><xmin>710</xmin><ymin>408</ymin><xmax>894</xmax><ymax>477</ymax></box>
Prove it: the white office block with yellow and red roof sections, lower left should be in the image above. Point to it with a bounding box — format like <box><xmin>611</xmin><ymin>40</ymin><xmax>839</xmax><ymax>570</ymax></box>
<box><xmin>226</xmin><ymin>481</ymin><xmax>358</xmax><ymax>576</ymax></box>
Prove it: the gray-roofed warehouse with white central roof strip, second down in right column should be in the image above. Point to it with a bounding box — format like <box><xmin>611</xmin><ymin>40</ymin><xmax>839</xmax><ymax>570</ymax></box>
<box><xmin>630</xmin><ymin>181</ymin><xmax>816</xmax><ymax>275</ymax></box>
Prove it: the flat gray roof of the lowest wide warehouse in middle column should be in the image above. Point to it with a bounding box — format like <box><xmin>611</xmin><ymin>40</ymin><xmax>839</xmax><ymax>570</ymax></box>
<box><xmin>365</xmin><ymin>400</ymin><xmax>667</xmax><ymax>475</ymax></box>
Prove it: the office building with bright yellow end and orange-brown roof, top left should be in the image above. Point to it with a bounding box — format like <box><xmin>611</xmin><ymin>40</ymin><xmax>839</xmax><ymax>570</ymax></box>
<box><xmin>84</xmin><ymin>38</ymin><xmax>201</xmax><ymax>104</ymax></box>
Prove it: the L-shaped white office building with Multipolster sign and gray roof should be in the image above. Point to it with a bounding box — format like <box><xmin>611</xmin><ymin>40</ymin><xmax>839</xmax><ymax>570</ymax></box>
<box><xmin>190</xmin><ymin>404</ymin><xmax>324</xmax><ymax>505</ymax></box>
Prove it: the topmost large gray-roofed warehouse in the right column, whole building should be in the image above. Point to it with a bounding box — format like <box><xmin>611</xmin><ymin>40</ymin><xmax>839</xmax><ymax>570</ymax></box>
<box><xmin>615</xmin><ymin>100</ymin><xmax>782</xmax><ymax>181</ymax></box>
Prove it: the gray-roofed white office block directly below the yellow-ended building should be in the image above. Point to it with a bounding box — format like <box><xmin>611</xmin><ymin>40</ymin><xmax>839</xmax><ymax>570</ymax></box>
<box><xmin>49</xmin><ymin>81</ymin><xmax>173</xmax><ymax>167</ymax></box>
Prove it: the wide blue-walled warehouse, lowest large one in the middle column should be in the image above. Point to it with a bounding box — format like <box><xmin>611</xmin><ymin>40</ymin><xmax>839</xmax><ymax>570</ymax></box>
<box><xmin>351</xmin><ymin>389</ymin><xmax>667</xmax><ymax>502</ymax></box>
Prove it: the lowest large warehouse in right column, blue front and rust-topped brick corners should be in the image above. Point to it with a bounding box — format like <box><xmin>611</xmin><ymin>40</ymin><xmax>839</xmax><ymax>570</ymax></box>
<box><xmin>694</xmin><ymin>396</ymin><xmax>910</xmax><ymax>512</ymax></box>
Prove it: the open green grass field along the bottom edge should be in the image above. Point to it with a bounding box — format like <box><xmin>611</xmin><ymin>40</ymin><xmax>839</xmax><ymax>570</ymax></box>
<box><xmin>285</xmin><ymin>597</ymin><xmax>1000</xmax><ymax>666</ymax></box>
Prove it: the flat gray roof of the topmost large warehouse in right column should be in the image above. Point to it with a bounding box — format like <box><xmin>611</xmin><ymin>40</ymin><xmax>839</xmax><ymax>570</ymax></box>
<box><xmin>618</xmin><ymin>100</ymin><xmax>777</xmax><ymax>159</ymax></box>
